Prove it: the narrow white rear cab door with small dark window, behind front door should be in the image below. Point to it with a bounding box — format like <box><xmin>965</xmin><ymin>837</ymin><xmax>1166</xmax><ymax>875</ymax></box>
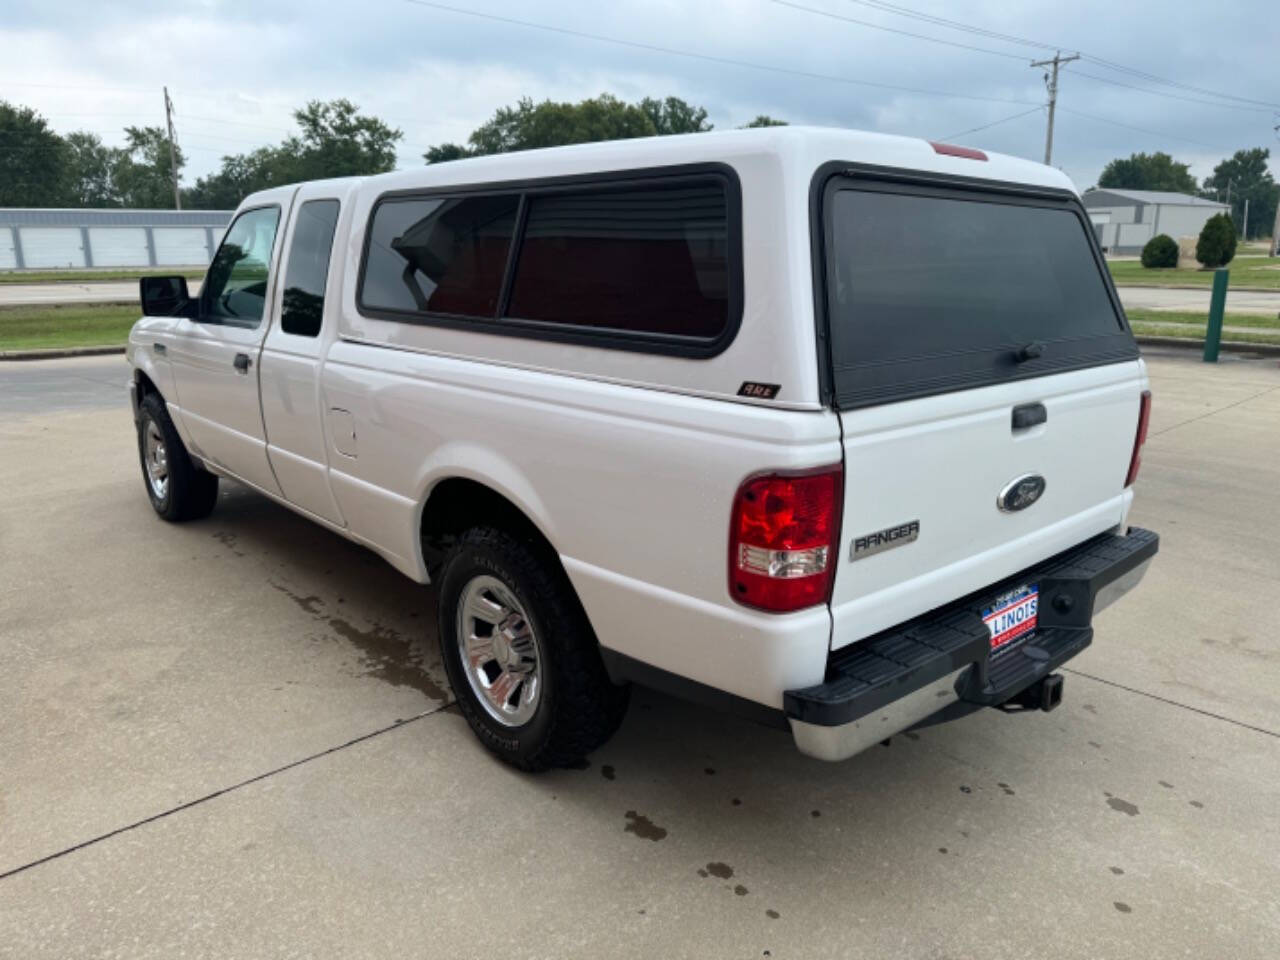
<box><xmin>259</xmin><ymin>183</ymin><xmax>348</xmax><ymax>524</ymax></box>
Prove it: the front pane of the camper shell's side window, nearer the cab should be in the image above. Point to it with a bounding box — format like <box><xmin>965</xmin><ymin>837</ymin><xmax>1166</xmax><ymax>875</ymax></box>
<box><xmin>360</xmin><ymin>193</ymin><xmax>520</xmax><ymax>317</ymax></box>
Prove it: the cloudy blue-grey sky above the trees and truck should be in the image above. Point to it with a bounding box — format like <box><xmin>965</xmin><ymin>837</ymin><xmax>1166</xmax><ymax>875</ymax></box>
<box><xmin>0</xmin><ymin>0</ymin><xmax>1280</xmax><ymax>188</ymax></box>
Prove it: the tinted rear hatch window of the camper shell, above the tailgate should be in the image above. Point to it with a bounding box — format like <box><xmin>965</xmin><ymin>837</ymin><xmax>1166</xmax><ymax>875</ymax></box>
<box><xmin>826</xmin><ymin>184</ymin><xmax>1138</xmax><ymax>407</ymax></box>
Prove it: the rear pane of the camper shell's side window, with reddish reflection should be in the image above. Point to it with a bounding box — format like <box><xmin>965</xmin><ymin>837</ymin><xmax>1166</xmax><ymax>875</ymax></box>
<box><xmin>508</xmin><ymin>180</ymin><xmax>730</xmax><ymax>339</ymax></box>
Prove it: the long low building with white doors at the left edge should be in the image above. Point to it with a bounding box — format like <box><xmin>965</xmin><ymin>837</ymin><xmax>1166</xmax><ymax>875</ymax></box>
<box><xmin>0</xmin><ymin>207</ymin><xmax>233</xmax><ymax>270</ymax></box>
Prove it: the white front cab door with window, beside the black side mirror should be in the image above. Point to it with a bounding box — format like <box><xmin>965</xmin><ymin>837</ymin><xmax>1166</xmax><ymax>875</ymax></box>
<box><xmin>169</xmin><ymin>194</ymin><xmax>294</xmax><ymax>495</ymax></box>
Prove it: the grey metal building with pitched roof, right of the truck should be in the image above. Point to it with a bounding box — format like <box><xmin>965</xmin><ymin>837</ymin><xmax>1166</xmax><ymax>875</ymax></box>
<box><xmin>1082</xmin><ymin>187</ymin><xmax>1230</xmax><ymax>253</ymax></box>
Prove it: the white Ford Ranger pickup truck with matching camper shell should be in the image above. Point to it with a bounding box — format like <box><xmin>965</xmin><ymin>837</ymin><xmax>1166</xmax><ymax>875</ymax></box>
<box><xmin>128</xmin><ymin>128</ymin><xmax>1158</xmax><ymax>769</ymax></box>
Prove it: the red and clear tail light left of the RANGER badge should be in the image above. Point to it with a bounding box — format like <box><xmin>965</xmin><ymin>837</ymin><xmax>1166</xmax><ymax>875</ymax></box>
<box><xmin>728</xmin><ymin>465</ymin><xmax>844</xmax><ymax>613</ymax></box>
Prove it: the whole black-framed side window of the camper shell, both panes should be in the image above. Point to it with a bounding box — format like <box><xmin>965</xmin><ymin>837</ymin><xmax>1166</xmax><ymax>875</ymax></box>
<box><xmin>357</xmin><ymin>166</ymin><xmax>742</xmax><ymax>356</ymax></box>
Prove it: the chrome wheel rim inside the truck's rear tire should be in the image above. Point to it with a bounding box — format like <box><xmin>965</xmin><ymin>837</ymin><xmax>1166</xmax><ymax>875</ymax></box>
<box><xmin>457</xmin><ymin>575</ymin><xmax>543</xmax><ymax>727</ymax></box>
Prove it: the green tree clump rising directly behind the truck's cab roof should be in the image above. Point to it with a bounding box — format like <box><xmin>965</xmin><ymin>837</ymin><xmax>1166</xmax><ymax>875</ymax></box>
<box><xmin>184</xmin><ymin>100</ymin><xmax>404</xmax><ymax>210</ymax></box>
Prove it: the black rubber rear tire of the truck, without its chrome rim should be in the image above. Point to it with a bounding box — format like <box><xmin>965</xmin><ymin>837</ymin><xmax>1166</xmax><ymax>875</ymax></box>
<box><xmin>439</xmin><ymin>527</ymin><xmax>630</xmax><ymax>771</ymax></box>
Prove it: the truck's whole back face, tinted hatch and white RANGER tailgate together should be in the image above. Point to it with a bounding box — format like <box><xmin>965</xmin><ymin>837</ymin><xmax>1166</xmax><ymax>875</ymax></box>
<box><xmin>822</xmin><ymin>170</ymin><xmax>1147</xmax><ymax>646</ymax></box>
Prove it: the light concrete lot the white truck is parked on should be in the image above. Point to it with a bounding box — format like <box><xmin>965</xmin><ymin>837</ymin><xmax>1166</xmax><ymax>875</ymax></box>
<box><xmin>0</xmin><ymin>355</ymin><xmax>1280</xmax><ymax>960</ymax></box>
